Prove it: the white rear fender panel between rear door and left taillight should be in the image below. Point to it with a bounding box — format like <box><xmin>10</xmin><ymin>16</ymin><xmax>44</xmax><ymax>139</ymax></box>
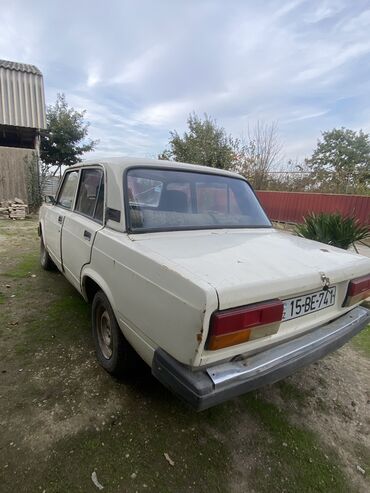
<box><xmin>90</xmin><ymin>229</ymin><xmax>218</xmax><ymax>365</ymax></box>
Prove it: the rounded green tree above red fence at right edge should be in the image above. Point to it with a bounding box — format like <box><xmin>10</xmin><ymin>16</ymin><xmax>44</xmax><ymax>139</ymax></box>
<box><xmin>307</xmin><ymin>127</ymin><xmax>370</xmax><ymax>193</ymax></box>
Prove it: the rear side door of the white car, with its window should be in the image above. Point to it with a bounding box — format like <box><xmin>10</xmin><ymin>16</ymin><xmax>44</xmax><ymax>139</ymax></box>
<box><xmin>61</xmin><ymin>167</ymin><xmax>105</xmax><ymax>289</ymax></box>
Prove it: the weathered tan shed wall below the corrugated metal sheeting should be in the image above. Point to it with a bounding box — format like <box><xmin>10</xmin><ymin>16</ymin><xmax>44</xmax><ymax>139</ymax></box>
<box><xmin>0</xmin><ymin>147</ymin><xmax>35</xmax><ymax>203</ymax></box>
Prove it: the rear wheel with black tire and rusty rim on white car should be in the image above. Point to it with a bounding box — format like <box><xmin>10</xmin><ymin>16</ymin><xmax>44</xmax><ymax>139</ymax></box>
<box><xmin>91</xmin><ymin>291</ymin><xmax>138</xmax><ymax>377</ymax></box>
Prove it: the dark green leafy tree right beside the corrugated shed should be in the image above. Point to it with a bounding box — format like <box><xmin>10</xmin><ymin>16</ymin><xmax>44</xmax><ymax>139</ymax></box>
<box><xmin>40</xmin><ymin>94</ymin><xmax>98</xmax><ymax>175</ymax></box>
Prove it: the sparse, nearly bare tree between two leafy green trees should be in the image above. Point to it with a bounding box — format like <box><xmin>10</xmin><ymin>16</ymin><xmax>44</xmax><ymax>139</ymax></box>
<box><xmin>237</xmin><ymin>121</ymin><xmax>282</xmax><ymax>190</ymax></box>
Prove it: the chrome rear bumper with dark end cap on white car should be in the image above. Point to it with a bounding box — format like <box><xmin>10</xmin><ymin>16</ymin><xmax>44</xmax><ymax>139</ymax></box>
<box><xmin>152</xmin><ymin>307</ymin><xmax>370</xmax><ymax>411</ymax></box>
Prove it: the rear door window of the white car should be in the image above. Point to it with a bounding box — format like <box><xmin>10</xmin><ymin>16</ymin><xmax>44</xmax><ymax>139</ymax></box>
<box><xmin>75</xmin><ymin>169</ymin><xmax>104</xmax><ymax>221</ymax></box>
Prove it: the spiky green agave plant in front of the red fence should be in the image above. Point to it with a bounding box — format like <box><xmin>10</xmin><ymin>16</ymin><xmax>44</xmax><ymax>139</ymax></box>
<box><xmin>295</xmin><ymin>212</ymin><xmax>370</xmax><ymax>250</ymax></box>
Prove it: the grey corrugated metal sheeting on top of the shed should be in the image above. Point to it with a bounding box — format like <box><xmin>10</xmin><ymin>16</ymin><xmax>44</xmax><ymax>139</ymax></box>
<box><xmin>0</xmin><ymin>60</ymin><xmax>46</xmax><ymax>129</ymax></box>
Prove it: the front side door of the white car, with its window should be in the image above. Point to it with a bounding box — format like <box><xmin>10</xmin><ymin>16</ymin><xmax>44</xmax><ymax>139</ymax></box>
<box><xmin>44</xmin><ymin>170</ymin><xmax>79</xmax><ymax>269</ymax></box>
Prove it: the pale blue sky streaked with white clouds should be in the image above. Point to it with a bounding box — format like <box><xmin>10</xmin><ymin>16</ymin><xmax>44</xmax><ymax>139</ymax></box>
<box><xmin>0</xmin><ymin>0</ymin><xmax>370</xmax><ymax>165</ymax></box>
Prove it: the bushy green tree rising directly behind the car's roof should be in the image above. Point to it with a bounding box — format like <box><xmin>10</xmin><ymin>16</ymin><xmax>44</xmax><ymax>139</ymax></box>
<box><xmin>158</xmin><ymin>113</ymin><xmax>237</xmax><ymax>169</ymax></box>
